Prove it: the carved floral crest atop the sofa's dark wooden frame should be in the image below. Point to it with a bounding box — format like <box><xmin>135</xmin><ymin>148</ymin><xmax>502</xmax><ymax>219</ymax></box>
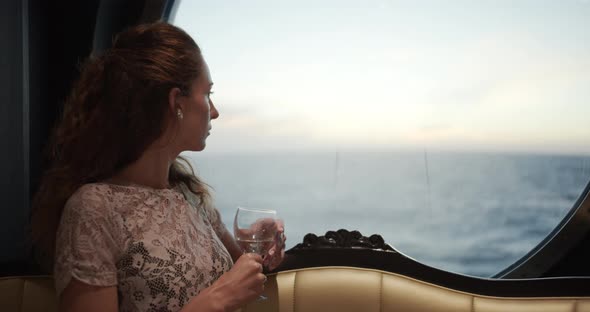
<box><xmin>292</xmin><ymin>229</ymin><xmax>395</xmax><ymax>251</ymax></box>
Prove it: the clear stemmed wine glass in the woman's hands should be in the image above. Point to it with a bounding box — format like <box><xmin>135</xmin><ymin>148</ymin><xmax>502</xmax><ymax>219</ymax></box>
<box><xmin>234</xmin><ymin>207</ymin><xmax>277</xmax><ymax>300</ymax></box>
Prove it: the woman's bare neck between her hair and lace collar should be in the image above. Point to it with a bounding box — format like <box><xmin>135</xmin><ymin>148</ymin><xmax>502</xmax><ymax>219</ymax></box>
<box><xmin>107</xmin><ymin>149</ymin><xmax>176</xmax><ymax>189</ymax></box>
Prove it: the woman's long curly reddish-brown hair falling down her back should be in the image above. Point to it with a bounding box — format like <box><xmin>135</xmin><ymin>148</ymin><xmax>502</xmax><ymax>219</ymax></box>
<box><xmin>31</xmin><ymin>22</ymin><xmax>210</xmax><ymax>270</ymax></box>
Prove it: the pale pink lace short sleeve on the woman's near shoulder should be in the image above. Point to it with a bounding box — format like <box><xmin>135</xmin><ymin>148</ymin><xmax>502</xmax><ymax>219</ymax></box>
<box><xmin>54</xmin><ymin>186</ymin><xmax>120</xmax><ymax>295</ymax></box>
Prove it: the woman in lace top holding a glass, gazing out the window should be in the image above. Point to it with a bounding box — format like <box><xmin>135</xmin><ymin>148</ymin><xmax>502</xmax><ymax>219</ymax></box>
<box><xmin>32</xmin><ymin>22</ymin><xmax>284</xmax><ymax>311</ymax></box>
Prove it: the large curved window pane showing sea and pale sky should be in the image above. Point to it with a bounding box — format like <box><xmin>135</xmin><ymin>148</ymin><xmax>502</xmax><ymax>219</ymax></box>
<box><xmin>174</xmin><ymin>0</ymin><xmax>590</xmax><ymax>276</ymax></box>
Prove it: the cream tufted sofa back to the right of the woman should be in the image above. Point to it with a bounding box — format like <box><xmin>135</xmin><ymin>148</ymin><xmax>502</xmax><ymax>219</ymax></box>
<box><xmin>243</xmin><ymin>267</ymin><xmax>590</xmax><ymax>312</ymax></box>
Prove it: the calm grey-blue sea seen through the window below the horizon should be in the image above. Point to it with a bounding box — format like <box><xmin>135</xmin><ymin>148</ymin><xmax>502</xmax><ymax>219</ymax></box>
<box><xmin>185</xmin><ymin>151</ymin><xmax>590</xmax><ymax>277</ymax></box>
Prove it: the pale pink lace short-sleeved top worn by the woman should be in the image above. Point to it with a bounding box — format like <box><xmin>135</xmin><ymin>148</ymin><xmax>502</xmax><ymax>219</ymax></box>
<box><xmin>54</xmin><ymin>183</ymin><xmax>233</xmax><ymax>311</ymax></box>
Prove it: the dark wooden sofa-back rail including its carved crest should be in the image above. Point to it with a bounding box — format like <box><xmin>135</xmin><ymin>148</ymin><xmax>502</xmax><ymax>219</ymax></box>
<box><xmin>278</xmin><ymin>230</ymin><xmax>590</xmax><ymax>297</ymax></box>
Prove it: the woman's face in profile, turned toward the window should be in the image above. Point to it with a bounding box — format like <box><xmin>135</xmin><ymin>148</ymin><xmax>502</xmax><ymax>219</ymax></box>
<box><xmin>178</xmin><ymin>61</ymin><xmax>219</xmax><ymax>151</ymax></box>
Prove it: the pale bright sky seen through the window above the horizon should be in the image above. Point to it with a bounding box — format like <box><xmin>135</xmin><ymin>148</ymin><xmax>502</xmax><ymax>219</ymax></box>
<box><xmin>173</xmin><ymin>0</ymin><xmax>590</xmax><ymax>155</ymax></box>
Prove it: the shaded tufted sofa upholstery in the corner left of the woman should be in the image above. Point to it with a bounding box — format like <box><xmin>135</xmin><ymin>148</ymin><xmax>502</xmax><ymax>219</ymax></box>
<box><xmin>0</xmin><ymin>276</ymin><xmax>57</xmax><ymax>312</ymax></box>
